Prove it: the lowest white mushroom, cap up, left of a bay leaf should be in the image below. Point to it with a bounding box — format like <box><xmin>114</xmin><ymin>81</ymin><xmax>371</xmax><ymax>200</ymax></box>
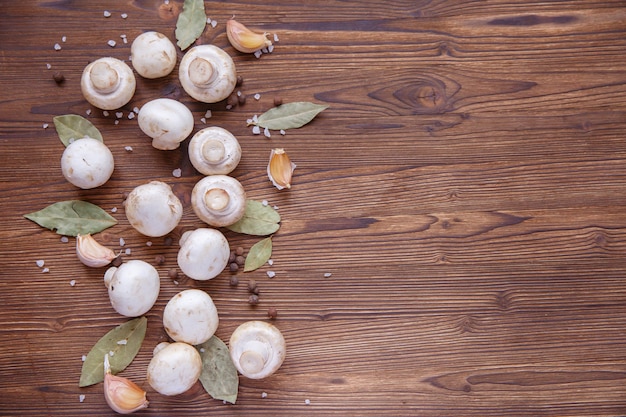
<box><xmin>147</xmin><ymin>342</ymin><xmax>202</xmax><ymax>395</ymax></box>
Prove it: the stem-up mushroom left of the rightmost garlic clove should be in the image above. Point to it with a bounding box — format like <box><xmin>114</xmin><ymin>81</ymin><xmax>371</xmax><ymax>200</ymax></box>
<box><xmin>188</xmin><ymin>126</ymin><xmax>241</xmax><ymax>175</ymax></box>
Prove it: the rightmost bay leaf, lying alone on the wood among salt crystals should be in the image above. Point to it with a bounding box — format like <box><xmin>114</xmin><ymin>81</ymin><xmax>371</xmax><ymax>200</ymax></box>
<box><xmin>254</xmin><ymin>101</ymin><xmax>328</xmax><ymax>130</ymax></box>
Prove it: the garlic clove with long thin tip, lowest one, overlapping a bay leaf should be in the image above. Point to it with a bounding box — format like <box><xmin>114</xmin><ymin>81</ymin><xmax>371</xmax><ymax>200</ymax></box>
<box><xmin>104</xmin><ymin>354</ymin><xmax>149</xmax><ymax>414</ymax></box>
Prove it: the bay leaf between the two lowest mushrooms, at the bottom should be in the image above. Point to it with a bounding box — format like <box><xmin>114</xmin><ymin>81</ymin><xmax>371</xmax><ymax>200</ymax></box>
<box><xmin>196</xmin><ymin>335</ymin><xmax>239</xmax><ymax>404</ymax></box>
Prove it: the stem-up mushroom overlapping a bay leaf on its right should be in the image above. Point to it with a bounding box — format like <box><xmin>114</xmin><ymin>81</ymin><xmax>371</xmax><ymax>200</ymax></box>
<box><xmin>191</xmin><ymin>175</ymin><xmax>246</xmax><ymax>227</ymax></box>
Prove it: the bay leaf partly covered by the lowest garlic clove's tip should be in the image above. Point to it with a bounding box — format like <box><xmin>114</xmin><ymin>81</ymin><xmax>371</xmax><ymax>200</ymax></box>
<box><xmin>78</xmin><ymin>317</ymin><xmax>148</xmax><ymax>387</ymax></box>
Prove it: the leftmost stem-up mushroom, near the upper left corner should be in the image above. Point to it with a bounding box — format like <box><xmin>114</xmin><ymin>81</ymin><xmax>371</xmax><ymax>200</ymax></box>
<box><xmin>80</xmin><ymin>57</ymin><xmax>136</xmax><ymax>110</ymax></box>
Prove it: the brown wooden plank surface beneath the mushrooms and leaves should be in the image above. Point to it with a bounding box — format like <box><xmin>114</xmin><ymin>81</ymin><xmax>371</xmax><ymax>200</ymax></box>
<box><xmin>0</xmin><ymin>0</ymin><xmax>626</xmax><ymax>416</ymax></box>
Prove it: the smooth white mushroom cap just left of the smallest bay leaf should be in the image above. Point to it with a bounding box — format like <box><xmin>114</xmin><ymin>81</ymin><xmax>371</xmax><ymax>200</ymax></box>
<box><xmin>177</xmin><ymin>228</ymin><xmax>230</xmax><ymax>281</ymax></box>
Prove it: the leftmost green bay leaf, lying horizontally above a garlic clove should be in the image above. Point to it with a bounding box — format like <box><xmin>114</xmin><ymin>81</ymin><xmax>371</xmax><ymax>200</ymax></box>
<box><xmin>24</xmin><ymin>200</ymin><xmax>117</xmax><ymax>236</ymax></box>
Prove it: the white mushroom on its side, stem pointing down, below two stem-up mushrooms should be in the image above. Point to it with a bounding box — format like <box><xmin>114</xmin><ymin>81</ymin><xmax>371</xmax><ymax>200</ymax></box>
<box><xmin>137</xmin><ymin>98</ymin><xmax>194</xmax><ymax>150</ymax></box>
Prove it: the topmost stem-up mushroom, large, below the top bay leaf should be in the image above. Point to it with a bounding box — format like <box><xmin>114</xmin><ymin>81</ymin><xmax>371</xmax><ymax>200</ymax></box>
<box><xmin>178</xmin><ymin>44</ymin><xmax>237</xmax><ymax>103</ymax></box>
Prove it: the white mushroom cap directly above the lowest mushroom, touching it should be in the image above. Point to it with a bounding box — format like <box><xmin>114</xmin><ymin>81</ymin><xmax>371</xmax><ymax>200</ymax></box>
<box><xmin>163</xmin><ymin>289</ymin><xmax>219</xmax><ymax>345</ymax></box>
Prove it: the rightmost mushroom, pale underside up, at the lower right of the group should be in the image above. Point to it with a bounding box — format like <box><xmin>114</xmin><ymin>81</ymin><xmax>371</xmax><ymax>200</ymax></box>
<box><xmin>229</xmin><ymin>320</ymin><xmax>286</xmax><ymax>379</ymax></box>
